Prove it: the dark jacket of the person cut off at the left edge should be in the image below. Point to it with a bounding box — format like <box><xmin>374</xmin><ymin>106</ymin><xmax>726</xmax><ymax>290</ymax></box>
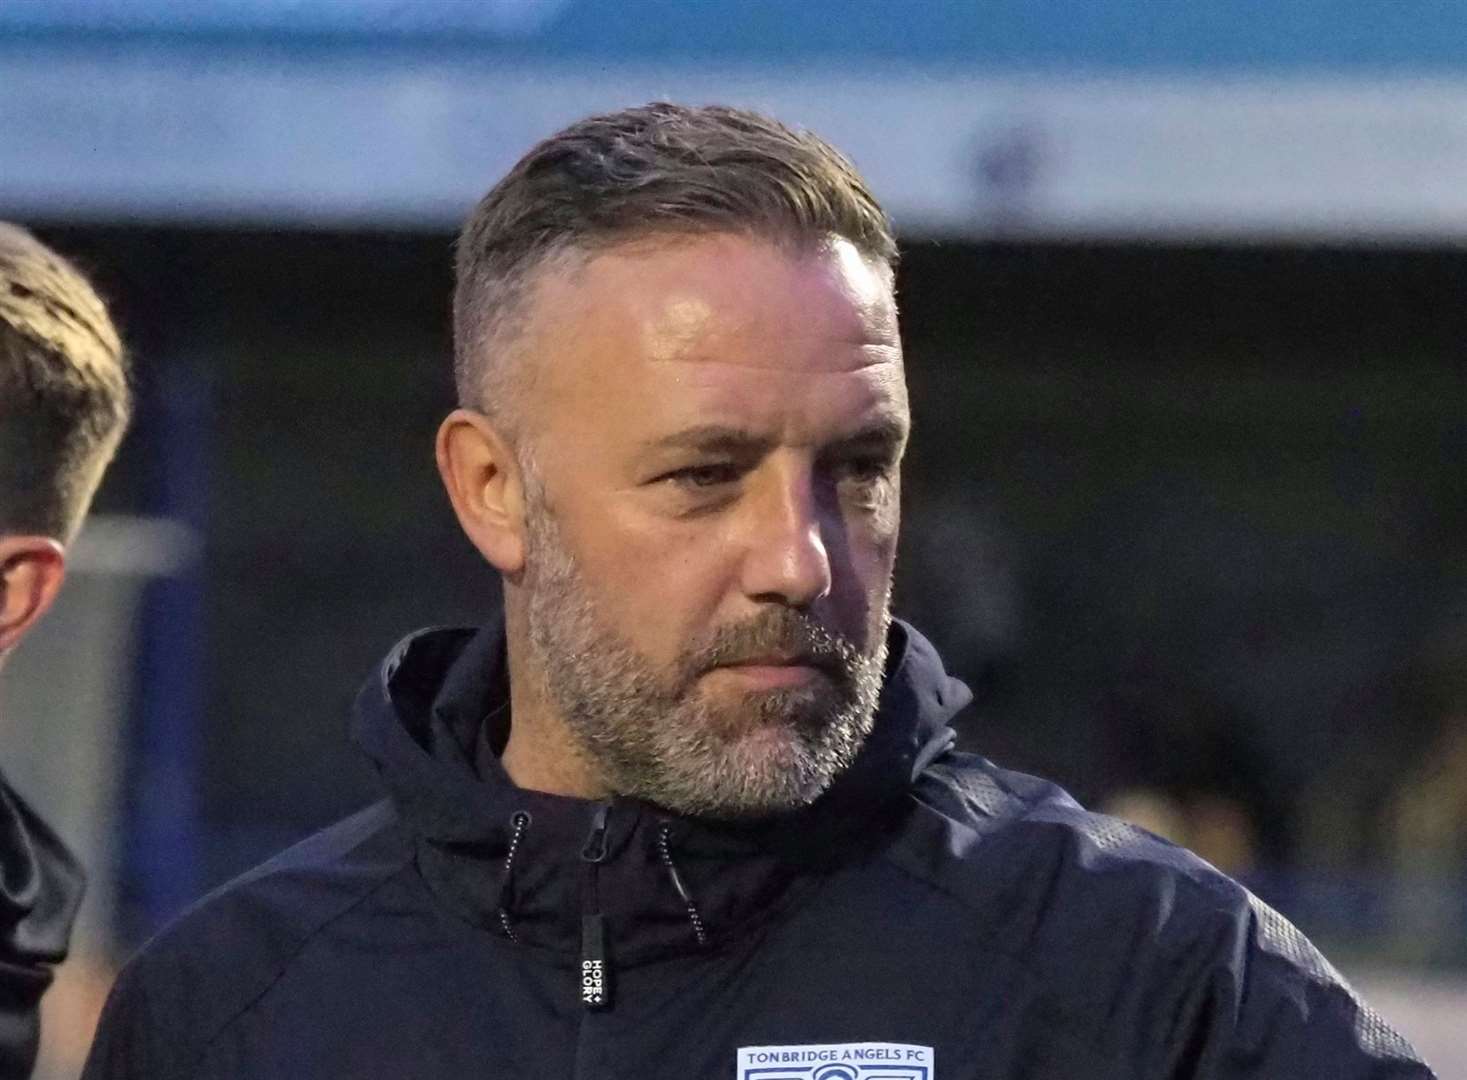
<box><xmin>0</xmin><ymin>778</ymin><xmax>82</xmax><ymax>1080</ymax></box>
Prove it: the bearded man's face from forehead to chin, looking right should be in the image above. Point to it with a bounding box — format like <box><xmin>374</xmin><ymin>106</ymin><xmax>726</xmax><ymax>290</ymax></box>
<box><xmin>522</xmin><ymin>236</ymin><xmax>908</xmax><ymax>816</ymax></box>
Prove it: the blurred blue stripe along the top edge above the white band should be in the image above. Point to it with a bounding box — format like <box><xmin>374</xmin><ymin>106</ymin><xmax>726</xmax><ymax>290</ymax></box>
<box><xmin>0</xmin><ymin>0</ymin><xmax>1467</xmax><ymax>73</ymax></box>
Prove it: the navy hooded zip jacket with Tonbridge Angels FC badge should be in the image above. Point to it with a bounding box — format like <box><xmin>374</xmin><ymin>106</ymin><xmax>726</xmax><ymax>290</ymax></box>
<box><xmin>77</xmin><ymin>624</ymin><xmax>1430</xmax><ymax>1080</ymax></box>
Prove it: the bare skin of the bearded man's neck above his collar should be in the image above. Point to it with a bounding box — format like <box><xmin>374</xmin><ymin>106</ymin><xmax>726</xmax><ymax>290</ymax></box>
<box><xmin>500</xmin><ymin>618</ymin><xmax>612</xmax><ymax>798</ymax></box>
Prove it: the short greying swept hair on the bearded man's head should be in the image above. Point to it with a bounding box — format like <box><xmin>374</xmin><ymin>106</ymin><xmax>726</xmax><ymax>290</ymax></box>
<box><xmin>453</xmin><ymin>103</ymin><xmax>896</xmax><ymax>430</ymax></box>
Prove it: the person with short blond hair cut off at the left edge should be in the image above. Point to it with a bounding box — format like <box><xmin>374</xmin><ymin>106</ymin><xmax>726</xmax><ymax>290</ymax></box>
<box><xmin>0</xmin><ymin>222</ymin><xmax>129</xmax><ymax>1077</ymax></box>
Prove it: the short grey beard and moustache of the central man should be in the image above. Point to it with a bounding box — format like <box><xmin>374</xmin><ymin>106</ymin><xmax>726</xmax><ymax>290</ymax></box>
<box><xmin>525</xmin><ymin>499</ymin><xmax>890</xmax><ymax>817</ymax></box>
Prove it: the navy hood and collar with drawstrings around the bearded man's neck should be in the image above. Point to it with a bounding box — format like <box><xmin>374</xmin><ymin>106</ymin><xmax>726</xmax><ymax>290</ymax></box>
<box><xmin>354</xmin><ymin>621</ymin><xmax>971</xmax><ymax>961</ymax></box>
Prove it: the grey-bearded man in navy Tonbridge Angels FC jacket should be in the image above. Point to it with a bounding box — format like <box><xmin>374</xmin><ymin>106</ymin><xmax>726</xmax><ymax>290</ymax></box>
<box><xmin>87</xmin><ymin>104</ymin><xmax>1429</xmax><ymax>1080</ymax></box>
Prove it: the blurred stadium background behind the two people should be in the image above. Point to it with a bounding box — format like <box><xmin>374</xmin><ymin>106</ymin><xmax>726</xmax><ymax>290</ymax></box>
<box><xmin>0</xmin><ymin>0</ymin><xmax>1467</xmax><ymax>1077</ymax></box>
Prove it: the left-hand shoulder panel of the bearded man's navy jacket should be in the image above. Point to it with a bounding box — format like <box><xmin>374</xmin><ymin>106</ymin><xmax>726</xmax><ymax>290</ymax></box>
<box><xmin>84</xmin><ymin>800</ymin><xmax>412</xmax><ymax>1080</ymax></box>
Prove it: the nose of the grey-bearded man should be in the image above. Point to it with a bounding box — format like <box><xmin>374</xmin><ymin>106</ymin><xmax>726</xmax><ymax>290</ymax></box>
<box><xmin>742</xmin><ymin>470</ymin><xmax>832</xmax><ymax>608</ymax></box>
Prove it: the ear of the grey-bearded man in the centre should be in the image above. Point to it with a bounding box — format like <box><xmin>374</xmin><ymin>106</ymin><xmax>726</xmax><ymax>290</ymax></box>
<box><xmin>436</xmin><ymin>409</ymin><xmax>525</xmax><ymax>577</ymax></box>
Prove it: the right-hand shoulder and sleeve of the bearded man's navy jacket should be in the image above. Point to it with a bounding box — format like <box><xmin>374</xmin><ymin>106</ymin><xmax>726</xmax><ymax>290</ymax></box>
<box><xmin>898</xmin><ymin>753</ymin><xmax>1430</xmax><ymax>1077</ymax></box>
